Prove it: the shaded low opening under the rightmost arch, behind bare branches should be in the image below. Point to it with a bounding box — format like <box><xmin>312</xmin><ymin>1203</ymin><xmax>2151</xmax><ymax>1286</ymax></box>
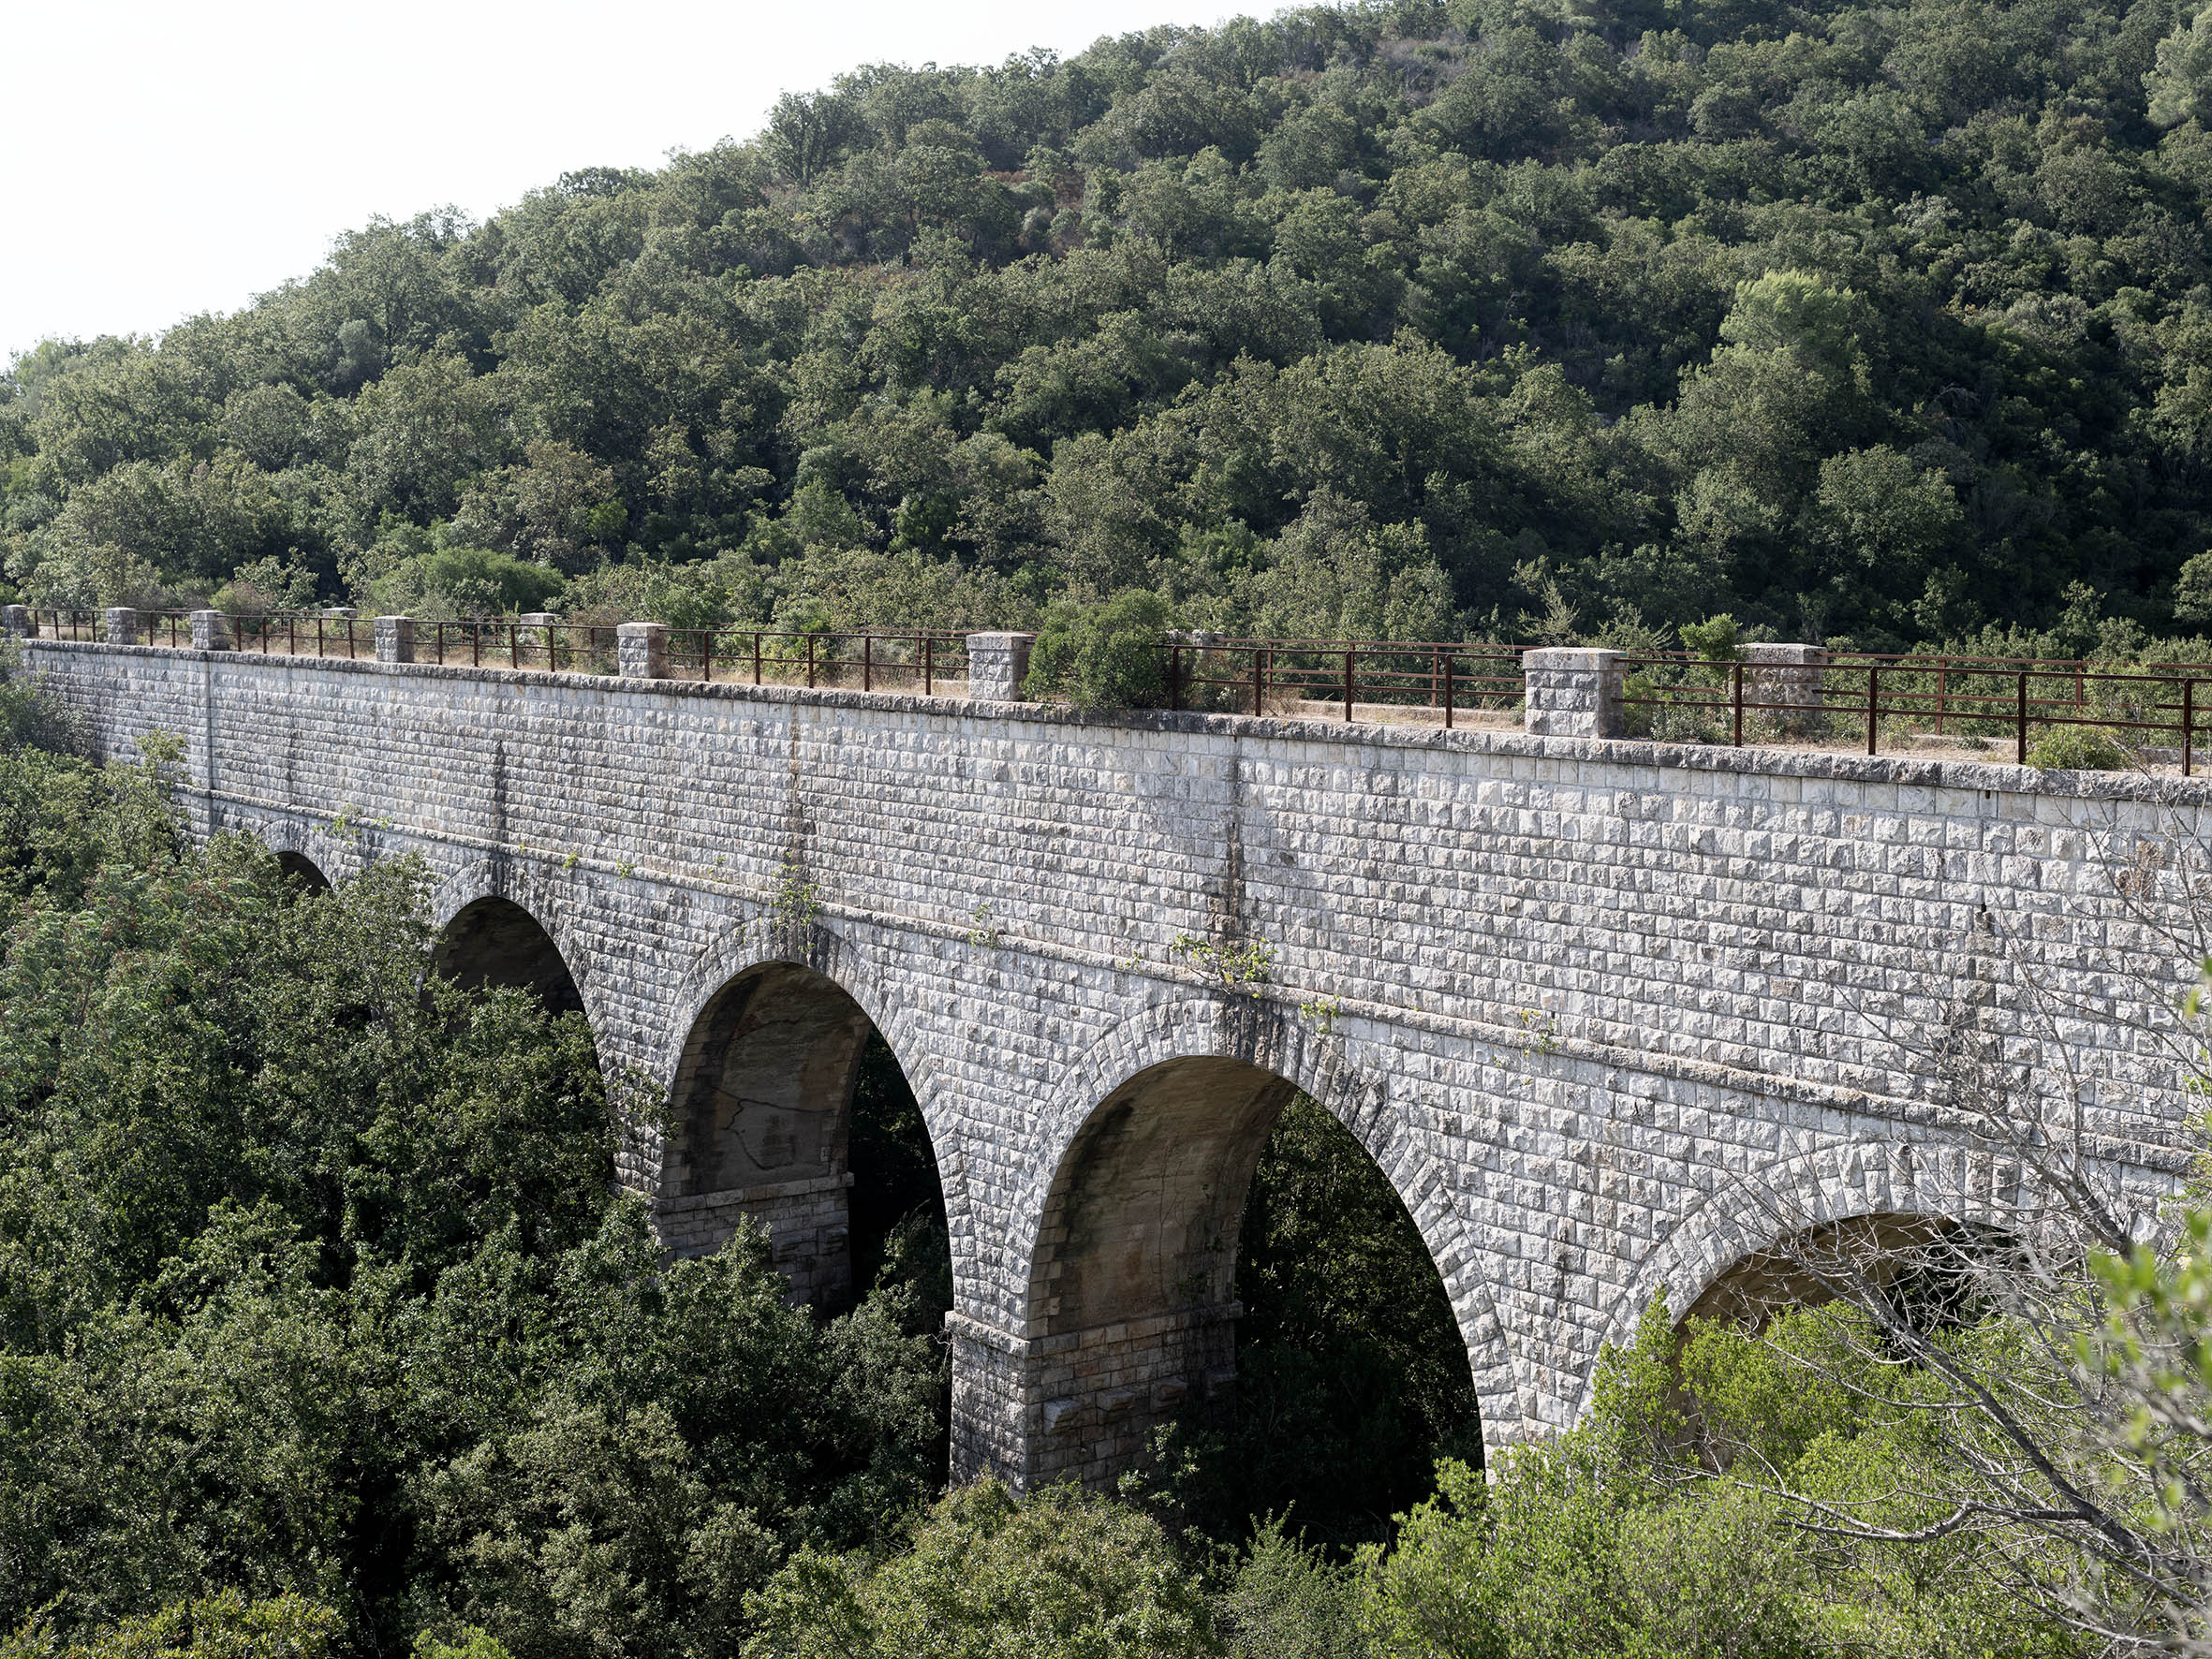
<box><xmin>1681</xmin><ymin>1212</ymin><xmax>1999</xmax><ymax>1329</ymax></box>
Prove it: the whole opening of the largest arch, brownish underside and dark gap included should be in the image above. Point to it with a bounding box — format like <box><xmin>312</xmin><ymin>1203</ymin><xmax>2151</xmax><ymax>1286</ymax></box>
<box><xmin>1031</xmin><ymin>1057</ymin><xmax>1482</xmax><ymax>1544</ymax></box>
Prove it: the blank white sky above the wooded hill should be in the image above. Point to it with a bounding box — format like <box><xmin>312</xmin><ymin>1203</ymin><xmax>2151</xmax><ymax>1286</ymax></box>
<box><xmin>0</xmin><ymin>0</ymin><xmax>1230</xmax><ymax>360</ymax></box>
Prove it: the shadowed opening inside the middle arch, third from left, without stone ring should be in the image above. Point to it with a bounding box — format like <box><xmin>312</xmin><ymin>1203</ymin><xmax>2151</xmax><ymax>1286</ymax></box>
<box><xmin>659</xmin><ymin>958</ymin><xmax>949</xmax><ymax>1307</ymax></box>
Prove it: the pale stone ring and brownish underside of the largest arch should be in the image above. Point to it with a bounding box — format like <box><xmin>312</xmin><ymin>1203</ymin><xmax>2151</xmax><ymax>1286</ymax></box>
<box><xmin>999</xmin><ymin>998</ymin><xmax>1520</xmax><ymax>1482</ymax></box>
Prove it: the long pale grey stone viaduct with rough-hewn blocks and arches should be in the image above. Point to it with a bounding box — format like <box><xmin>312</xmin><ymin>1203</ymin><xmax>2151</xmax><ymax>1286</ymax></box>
<box><xmin>12</xmin><ymin>639</ymin><xmax>2212</xmax><ymax>1480</ymax></box>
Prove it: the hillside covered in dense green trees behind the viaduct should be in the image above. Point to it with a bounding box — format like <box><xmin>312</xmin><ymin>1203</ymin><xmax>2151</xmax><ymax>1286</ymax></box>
<box><xmin>12</xmin><ymin>0</ymin><xmax>2212</xmax><ymax>651</ymax></box>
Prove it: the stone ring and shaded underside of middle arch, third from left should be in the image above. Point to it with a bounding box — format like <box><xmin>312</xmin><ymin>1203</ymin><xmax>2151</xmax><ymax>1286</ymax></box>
<box><xmin>657</xmin><ymin>925</ymin><xmax>942</xmax><ymax>1300</ymax></box>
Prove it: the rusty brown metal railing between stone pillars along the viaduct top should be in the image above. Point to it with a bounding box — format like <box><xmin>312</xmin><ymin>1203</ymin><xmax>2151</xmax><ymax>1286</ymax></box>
<box><xmin>34</xmin><ymin>606</ymin><xmax>2212</xmax><ymax>776</ymax></box>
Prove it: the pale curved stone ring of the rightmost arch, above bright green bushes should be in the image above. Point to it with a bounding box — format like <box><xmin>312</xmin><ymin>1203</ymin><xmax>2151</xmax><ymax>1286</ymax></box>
<box><xmin>1577</xmin><ymin>1137</ymin><xmax>2022</xmax><ymax>1416</ymax></box>
